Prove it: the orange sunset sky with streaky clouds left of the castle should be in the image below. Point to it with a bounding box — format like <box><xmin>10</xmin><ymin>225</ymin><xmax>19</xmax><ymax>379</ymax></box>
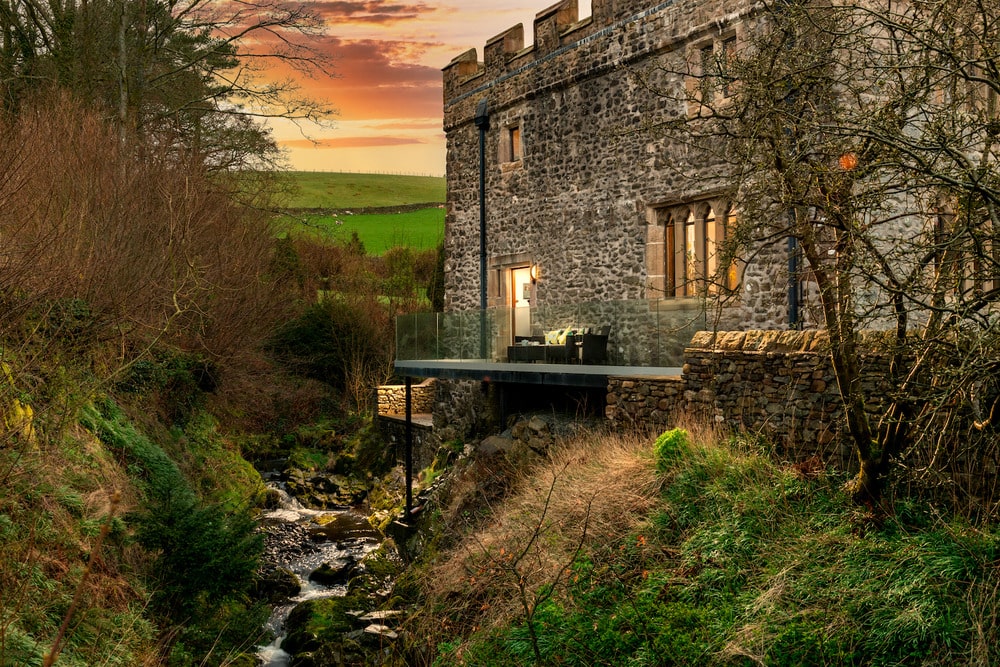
<box><xmin>273</xmin><ymin>0</ymin><xmax>590</xmax><ymax>176</ymax></box>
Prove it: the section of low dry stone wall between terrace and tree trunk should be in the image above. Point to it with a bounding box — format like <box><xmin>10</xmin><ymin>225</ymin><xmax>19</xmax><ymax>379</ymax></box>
<box><xmin>606</xmin><ymin>331</ymin><xmax>886</xmax><ymax>466</ymax></box>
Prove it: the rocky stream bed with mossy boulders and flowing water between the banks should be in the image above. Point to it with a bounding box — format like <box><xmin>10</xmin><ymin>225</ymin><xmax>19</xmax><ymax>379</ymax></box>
<box><xmin>257</xmin><ymin>471</ymin><xmax>410</xmax><ymax>667</ymax></box>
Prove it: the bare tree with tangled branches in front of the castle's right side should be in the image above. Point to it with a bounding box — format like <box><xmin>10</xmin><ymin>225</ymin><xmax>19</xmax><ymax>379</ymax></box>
<box><xmin>643</xmin><ymin>0</ymin><xmax>1000</xmax><ymax>502</ymax></box>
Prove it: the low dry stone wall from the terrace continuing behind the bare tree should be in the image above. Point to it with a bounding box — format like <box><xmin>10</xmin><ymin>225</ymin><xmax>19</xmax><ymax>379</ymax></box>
<box><xmin>606</xmin><ymin>331</ymin><xmax>1000</xmax><ymax>503</ymax></box>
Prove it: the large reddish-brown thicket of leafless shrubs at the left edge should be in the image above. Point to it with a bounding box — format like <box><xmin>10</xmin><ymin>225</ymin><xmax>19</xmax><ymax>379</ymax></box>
<box><xmin>0</xmin><ymin>96</ymin><xmax>283</xmax><ymax>376</ymax></box>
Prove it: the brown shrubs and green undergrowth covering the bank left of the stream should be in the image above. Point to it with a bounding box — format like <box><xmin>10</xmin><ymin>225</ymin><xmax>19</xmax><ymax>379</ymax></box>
<box><xmin>0</xmin><ymin>94</ymin><xmax>433</xmax><ymax>667</ymax></box>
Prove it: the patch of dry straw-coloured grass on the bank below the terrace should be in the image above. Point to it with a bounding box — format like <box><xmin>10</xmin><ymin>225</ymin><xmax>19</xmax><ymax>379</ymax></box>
<box><xmin>413</xmin><ymin>433</ymin><xmax>660</xmax><ymax>656</ymax></box>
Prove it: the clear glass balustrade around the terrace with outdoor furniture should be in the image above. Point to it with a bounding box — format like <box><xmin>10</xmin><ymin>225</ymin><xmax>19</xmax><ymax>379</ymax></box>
<box><xmin>396</xmin><ymin>299</ymin><xmax>705</xmax><ymax>367</ymax></box>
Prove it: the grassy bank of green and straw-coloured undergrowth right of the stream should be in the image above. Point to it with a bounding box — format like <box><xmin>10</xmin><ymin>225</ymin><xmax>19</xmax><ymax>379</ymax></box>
<box><xmin>404</xmin><ymin>431</ymin><xmax>1000</xmax><ymax>667</ymax></box>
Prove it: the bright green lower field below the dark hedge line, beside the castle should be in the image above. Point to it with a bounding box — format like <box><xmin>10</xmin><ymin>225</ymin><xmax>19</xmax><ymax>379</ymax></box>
<box><xmin>280</xmin><ymin>208</ymin><xmax>444</xmax><ymax>255</ymax></box>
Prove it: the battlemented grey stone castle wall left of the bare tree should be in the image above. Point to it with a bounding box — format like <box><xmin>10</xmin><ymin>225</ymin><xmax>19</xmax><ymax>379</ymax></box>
<box><xmin>444</xmin><ymin>0</ymin><xmax>788</xmax><ymax>328</ymax></box>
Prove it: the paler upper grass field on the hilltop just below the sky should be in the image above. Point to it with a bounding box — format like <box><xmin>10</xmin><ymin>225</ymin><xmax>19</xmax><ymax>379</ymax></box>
<box><xmin>276</xmin><ymin>171</ymin><xmax>445</xmax><ymax>209</ymax></box>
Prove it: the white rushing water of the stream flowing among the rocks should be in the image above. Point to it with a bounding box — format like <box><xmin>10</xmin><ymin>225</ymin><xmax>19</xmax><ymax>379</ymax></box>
<box><xmin>257</xmin><ymin>473</ymin><xmax>382</xmax><ymax>667</ymax></box>
